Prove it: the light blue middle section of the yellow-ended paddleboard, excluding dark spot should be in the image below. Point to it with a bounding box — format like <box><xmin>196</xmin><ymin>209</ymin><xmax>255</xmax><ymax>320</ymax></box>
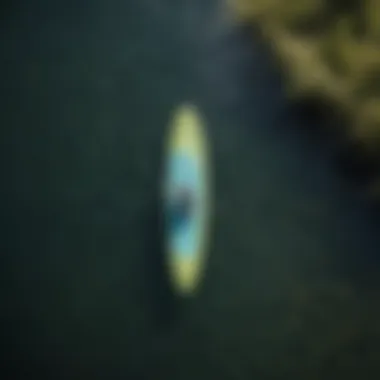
<box><xmin>165</xmin><ymin>153</ymin><xmax>204</xmax><ymax>257</ymax></box>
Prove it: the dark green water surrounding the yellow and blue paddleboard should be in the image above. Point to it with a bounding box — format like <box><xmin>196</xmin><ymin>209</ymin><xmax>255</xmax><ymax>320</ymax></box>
<box><xmin>1</xmin><ymin>0</ymin><xmax>380</xmax><ymax>380</ymax></box>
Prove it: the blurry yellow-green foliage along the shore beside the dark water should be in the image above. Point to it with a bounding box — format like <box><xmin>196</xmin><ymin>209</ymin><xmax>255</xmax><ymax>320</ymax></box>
<box><xmin>231</xmin><ymin>0</ymin><xmax>380</xmax><ymax>196</ymax></box>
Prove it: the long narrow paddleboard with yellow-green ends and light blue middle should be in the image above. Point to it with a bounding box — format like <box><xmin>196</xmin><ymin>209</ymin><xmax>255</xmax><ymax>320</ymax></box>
<box><xmin>164</xmin><ymin>104</ymin><xmax>210</xmax><ymax>296</ymax></box>
